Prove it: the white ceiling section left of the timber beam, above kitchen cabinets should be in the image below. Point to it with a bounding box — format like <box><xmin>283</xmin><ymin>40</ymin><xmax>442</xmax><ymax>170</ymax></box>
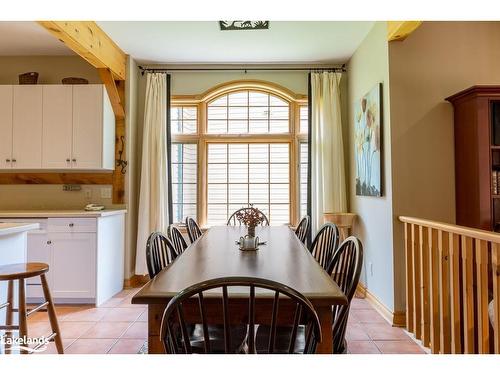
<box><xmin>0</xmin><ymin>21</ymin><xmax>74</xmax><ymax>56</ymax></box>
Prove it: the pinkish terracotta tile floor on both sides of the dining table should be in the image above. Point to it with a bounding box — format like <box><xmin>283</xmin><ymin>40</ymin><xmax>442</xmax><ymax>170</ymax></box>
<box><xmin>6</xmin><ymin>289</ymin><xmax>425</xmax><ymax>354</ymax></box>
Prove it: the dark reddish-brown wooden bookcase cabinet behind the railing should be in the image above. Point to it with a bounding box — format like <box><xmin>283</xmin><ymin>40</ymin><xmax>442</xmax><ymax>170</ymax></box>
<box><xmin>446</xmin><ymin>86</ymin><xmax>500</xmax><ymax>231</ymax></box>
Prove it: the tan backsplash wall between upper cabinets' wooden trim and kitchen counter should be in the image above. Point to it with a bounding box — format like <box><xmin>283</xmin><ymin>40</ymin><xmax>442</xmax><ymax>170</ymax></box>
<box><xmin>0</xmin><ymin>185</ymin><xmax>117</xmax><ymax>210</ymax></box>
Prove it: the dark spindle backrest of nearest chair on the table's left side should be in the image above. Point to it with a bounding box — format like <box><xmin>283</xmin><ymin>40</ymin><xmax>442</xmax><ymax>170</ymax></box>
<box><xmin>146</xmin><ymin>232</ymin><xmax>177</xmax><ymax>278</ymax></box>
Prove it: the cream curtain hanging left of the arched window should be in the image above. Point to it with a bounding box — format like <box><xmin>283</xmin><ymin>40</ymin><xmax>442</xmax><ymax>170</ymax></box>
<box><xmin>135</xmin><ymin>73</ymin><xmax>169</xmax><ymax>275</ymax></box>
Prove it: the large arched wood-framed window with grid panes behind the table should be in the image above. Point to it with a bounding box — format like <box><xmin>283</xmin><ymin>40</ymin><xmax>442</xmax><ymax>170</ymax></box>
<box><xmin>171</xmin><ymin>81</ymin><xmax>307</xmax><ymax>226</ymax></box>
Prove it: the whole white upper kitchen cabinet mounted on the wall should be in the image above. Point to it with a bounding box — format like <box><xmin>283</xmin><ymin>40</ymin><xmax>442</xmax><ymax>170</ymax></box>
<box><xmin>0</xmin><ymin>85</ymin><xmax>115</xmax><ymax>170</ymax></box>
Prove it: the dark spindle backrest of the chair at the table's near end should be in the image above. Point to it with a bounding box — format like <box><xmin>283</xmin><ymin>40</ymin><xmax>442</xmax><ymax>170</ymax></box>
<box><xmin>160</xmin><ymin>277</ymin><xmax>321</xmax><ymax>354</ymax></box>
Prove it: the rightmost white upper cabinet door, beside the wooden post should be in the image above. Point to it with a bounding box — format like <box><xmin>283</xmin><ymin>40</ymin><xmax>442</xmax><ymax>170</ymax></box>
<box><xmin>72</xmin><ymin>85</ymin><xmax>103</xmax><ymax>169</ymax></box>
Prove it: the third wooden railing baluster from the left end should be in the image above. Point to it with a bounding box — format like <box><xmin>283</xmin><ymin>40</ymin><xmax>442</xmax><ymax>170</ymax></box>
<box><xmin>418</xmin><ymin>226</ymin><xmax>430</xmax><ymax>347</ymax></box>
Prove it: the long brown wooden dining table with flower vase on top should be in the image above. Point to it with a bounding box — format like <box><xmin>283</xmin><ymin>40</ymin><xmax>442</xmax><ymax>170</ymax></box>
<box><xmin>132</xmin><ymin>226</ymin><xmax>347</xmax><ymax>354</ymax></box>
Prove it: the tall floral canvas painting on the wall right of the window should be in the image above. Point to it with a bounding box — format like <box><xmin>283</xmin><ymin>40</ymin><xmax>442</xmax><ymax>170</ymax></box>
<box><xmin>354</xmin><ymin>83</ymin><xmax>382</xmax><ymax>197</ymax></box>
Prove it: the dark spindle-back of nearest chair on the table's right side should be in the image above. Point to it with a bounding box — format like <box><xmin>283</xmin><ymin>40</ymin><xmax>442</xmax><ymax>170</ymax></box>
<box><xmin>328</xmin><ymin>236</ymin><xmax>363</xmax><ymax>353</ymax></box>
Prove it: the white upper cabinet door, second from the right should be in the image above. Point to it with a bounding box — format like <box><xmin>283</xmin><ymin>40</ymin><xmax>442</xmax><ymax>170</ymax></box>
<box><xmin>42</xmin><ymin>85</ymin><xmax>73</xmax><ymax>169</ymax></box>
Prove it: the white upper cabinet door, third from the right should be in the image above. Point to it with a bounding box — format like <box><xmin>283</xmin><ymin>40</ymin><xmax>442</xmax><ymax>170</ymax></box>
<box><xmin>12</xmin><ymin>85</ymin><xmax>42</xmax><ymax>169</ymax></box>
